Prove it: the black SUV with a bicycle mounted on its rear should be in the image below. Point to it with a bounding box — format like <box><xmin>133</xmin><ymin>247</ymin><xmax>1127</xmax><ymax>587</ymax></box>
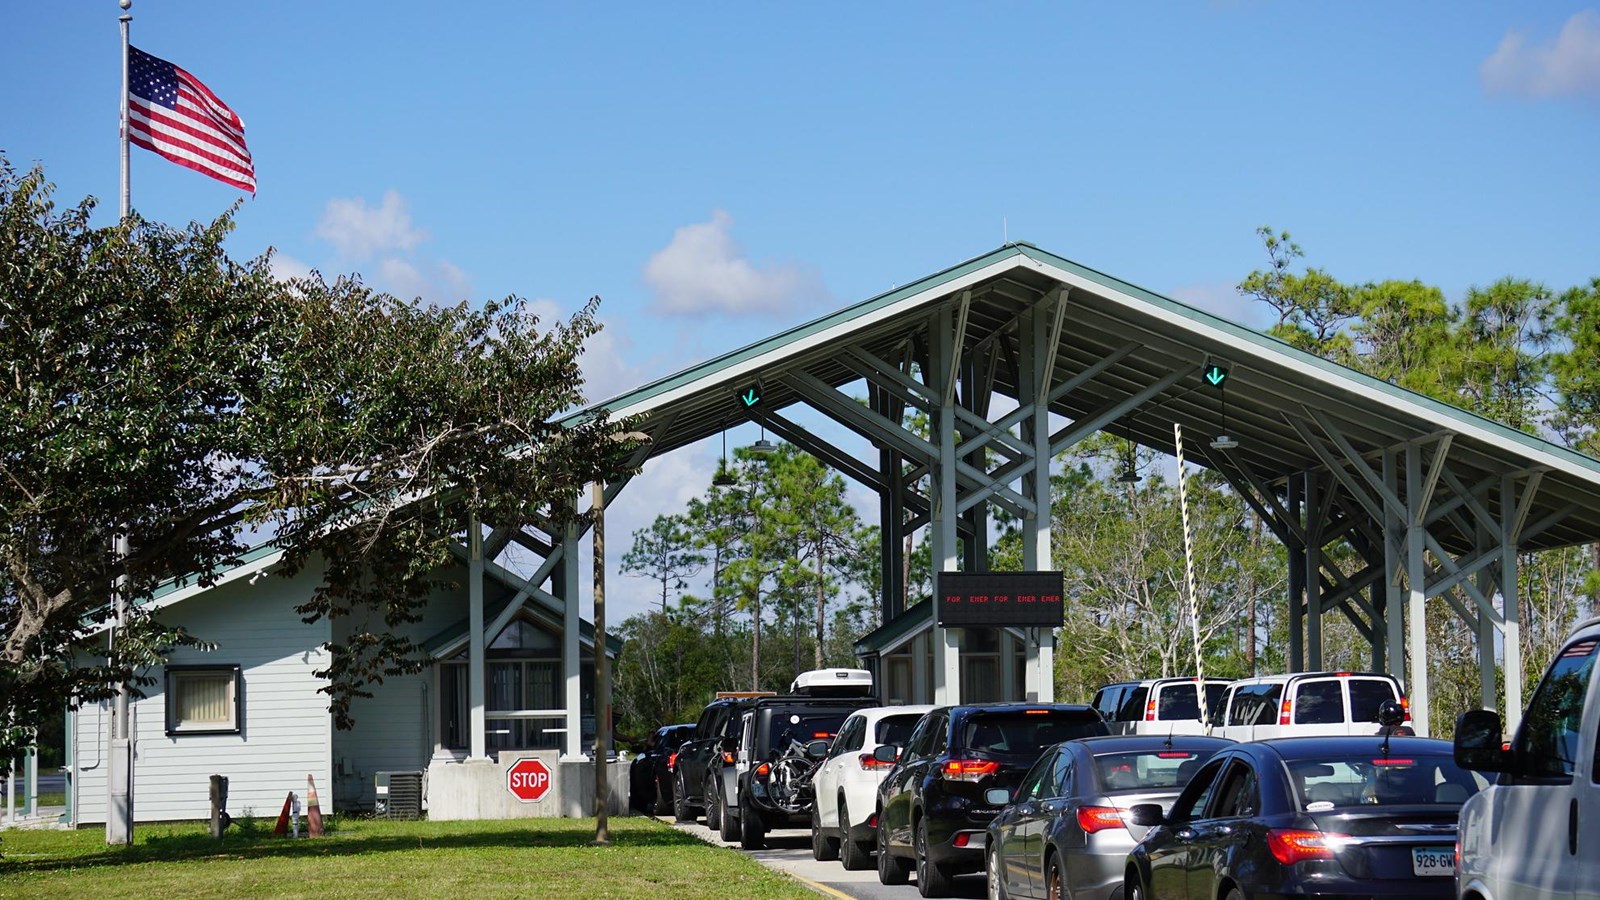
<box><xmin>722</xmin><ymin>697</ymin><xmax>878</xmax><ymax>850</ymax></box>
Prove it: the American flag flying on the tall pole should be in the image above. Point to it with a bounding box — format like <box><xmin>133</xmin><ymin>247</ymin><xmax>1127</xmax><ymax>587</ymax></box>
<box><xmin>128</xmin><ymin>46</ymin><xmax>256</xmax><ymax>194</ymax></box>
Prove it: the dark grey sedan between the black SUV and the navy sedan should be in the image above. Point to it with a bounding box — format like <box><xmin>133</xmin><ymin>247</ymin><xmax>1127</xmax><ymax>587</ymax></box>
<box><xmin>986</xmin><ymin>735</ymin><xmax>1234</xmax><ymax>900</ymax></box>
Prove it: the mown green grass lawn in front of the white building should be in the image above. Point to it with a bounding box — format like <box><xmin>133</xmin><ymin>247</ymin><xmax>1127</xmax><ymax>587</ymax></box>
<box><xmin>0</xmin><ymin>817</ymin><xmax>816</xmax><ymax>900</ymax></box>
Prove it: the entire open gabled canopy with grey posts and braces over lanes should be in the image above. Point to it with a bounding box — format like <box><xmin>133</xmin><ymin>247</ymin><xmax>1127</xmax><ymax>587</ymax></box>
<box><xmin>502</xmin><ymin>243</ymin><xmax>1600</xmax><ymax>735</ymax></box>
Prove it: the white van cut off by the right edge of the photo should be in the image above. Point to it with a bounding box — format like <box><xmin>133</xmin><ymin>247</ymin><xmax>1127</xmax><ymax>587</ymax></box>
<box><xmin>1456</xmin><ymin>617</ymin><xmax>1600</xmax><ymax>900</ymax></box>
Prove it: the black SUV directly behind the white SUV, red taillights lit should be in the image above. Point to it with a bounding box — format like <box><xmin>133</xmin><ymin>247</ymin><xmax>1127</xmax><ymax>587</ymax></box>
<box><xmin>875</xmin><ymin>703</ymin><xmax>1110</xmax><ymax>897</ymax></box>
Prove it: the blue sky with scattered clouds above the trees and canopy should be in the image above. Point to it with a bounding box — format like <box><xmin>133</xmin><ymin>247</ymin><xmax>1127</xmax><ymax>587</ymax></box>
<box><xmin>0</xmin><ymin>0</ymin><xmax>1600</xmax><ymax>614</ymax></box>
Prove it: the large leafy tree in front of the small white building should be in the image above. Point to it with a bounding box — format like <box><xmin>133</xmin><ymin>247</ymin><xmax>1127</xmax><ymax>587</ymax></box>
<box><xmin>0</xmin><ymin>159</ymin><xmax>626</xmax><ymax>759</ymax></box>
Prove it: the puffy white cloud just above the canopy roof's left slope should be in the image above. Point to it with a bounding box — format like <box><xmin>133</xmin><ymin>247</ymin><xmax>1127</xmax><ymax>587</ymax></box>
<box><xmin>645</xmin><ymin>210</ymin><xmax>827</xmax><ymax>315</ymax></box>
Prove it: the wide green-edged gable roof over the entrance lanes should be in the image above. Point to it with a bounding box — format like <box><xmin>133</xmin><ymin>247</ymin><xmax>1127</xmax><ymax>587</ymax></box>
<box><xmin>582</xmin><ymin>243</ymin><xmax>1600</xmax><ymax>549</ymax></box>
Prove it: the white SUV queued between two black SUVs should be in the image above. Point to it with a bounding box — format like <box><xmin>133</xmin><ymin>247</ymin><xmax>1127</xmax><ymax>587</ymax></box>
<box><xmin>811</xmin><ymin>706</ymin><xmax>933</xmax><ymax>870</ymax></box>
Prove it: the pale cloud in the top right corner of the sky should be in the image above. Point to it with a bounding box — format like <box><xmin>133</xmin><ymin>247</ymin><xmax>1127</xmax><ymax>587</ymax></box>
<box><xmin>1478</xmin><ymin>10</ymin><xmax>1600</xmax><ymax>99</ymax></box>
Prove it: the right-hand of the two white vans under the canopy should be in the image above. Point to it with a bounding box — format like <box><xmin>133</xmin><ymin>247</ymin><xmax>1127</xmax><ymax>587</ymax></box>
<box><xmin>1211</xmin><ymin>673</ymin><xmax>1411</xmax><ymax>741</ymax></box>
